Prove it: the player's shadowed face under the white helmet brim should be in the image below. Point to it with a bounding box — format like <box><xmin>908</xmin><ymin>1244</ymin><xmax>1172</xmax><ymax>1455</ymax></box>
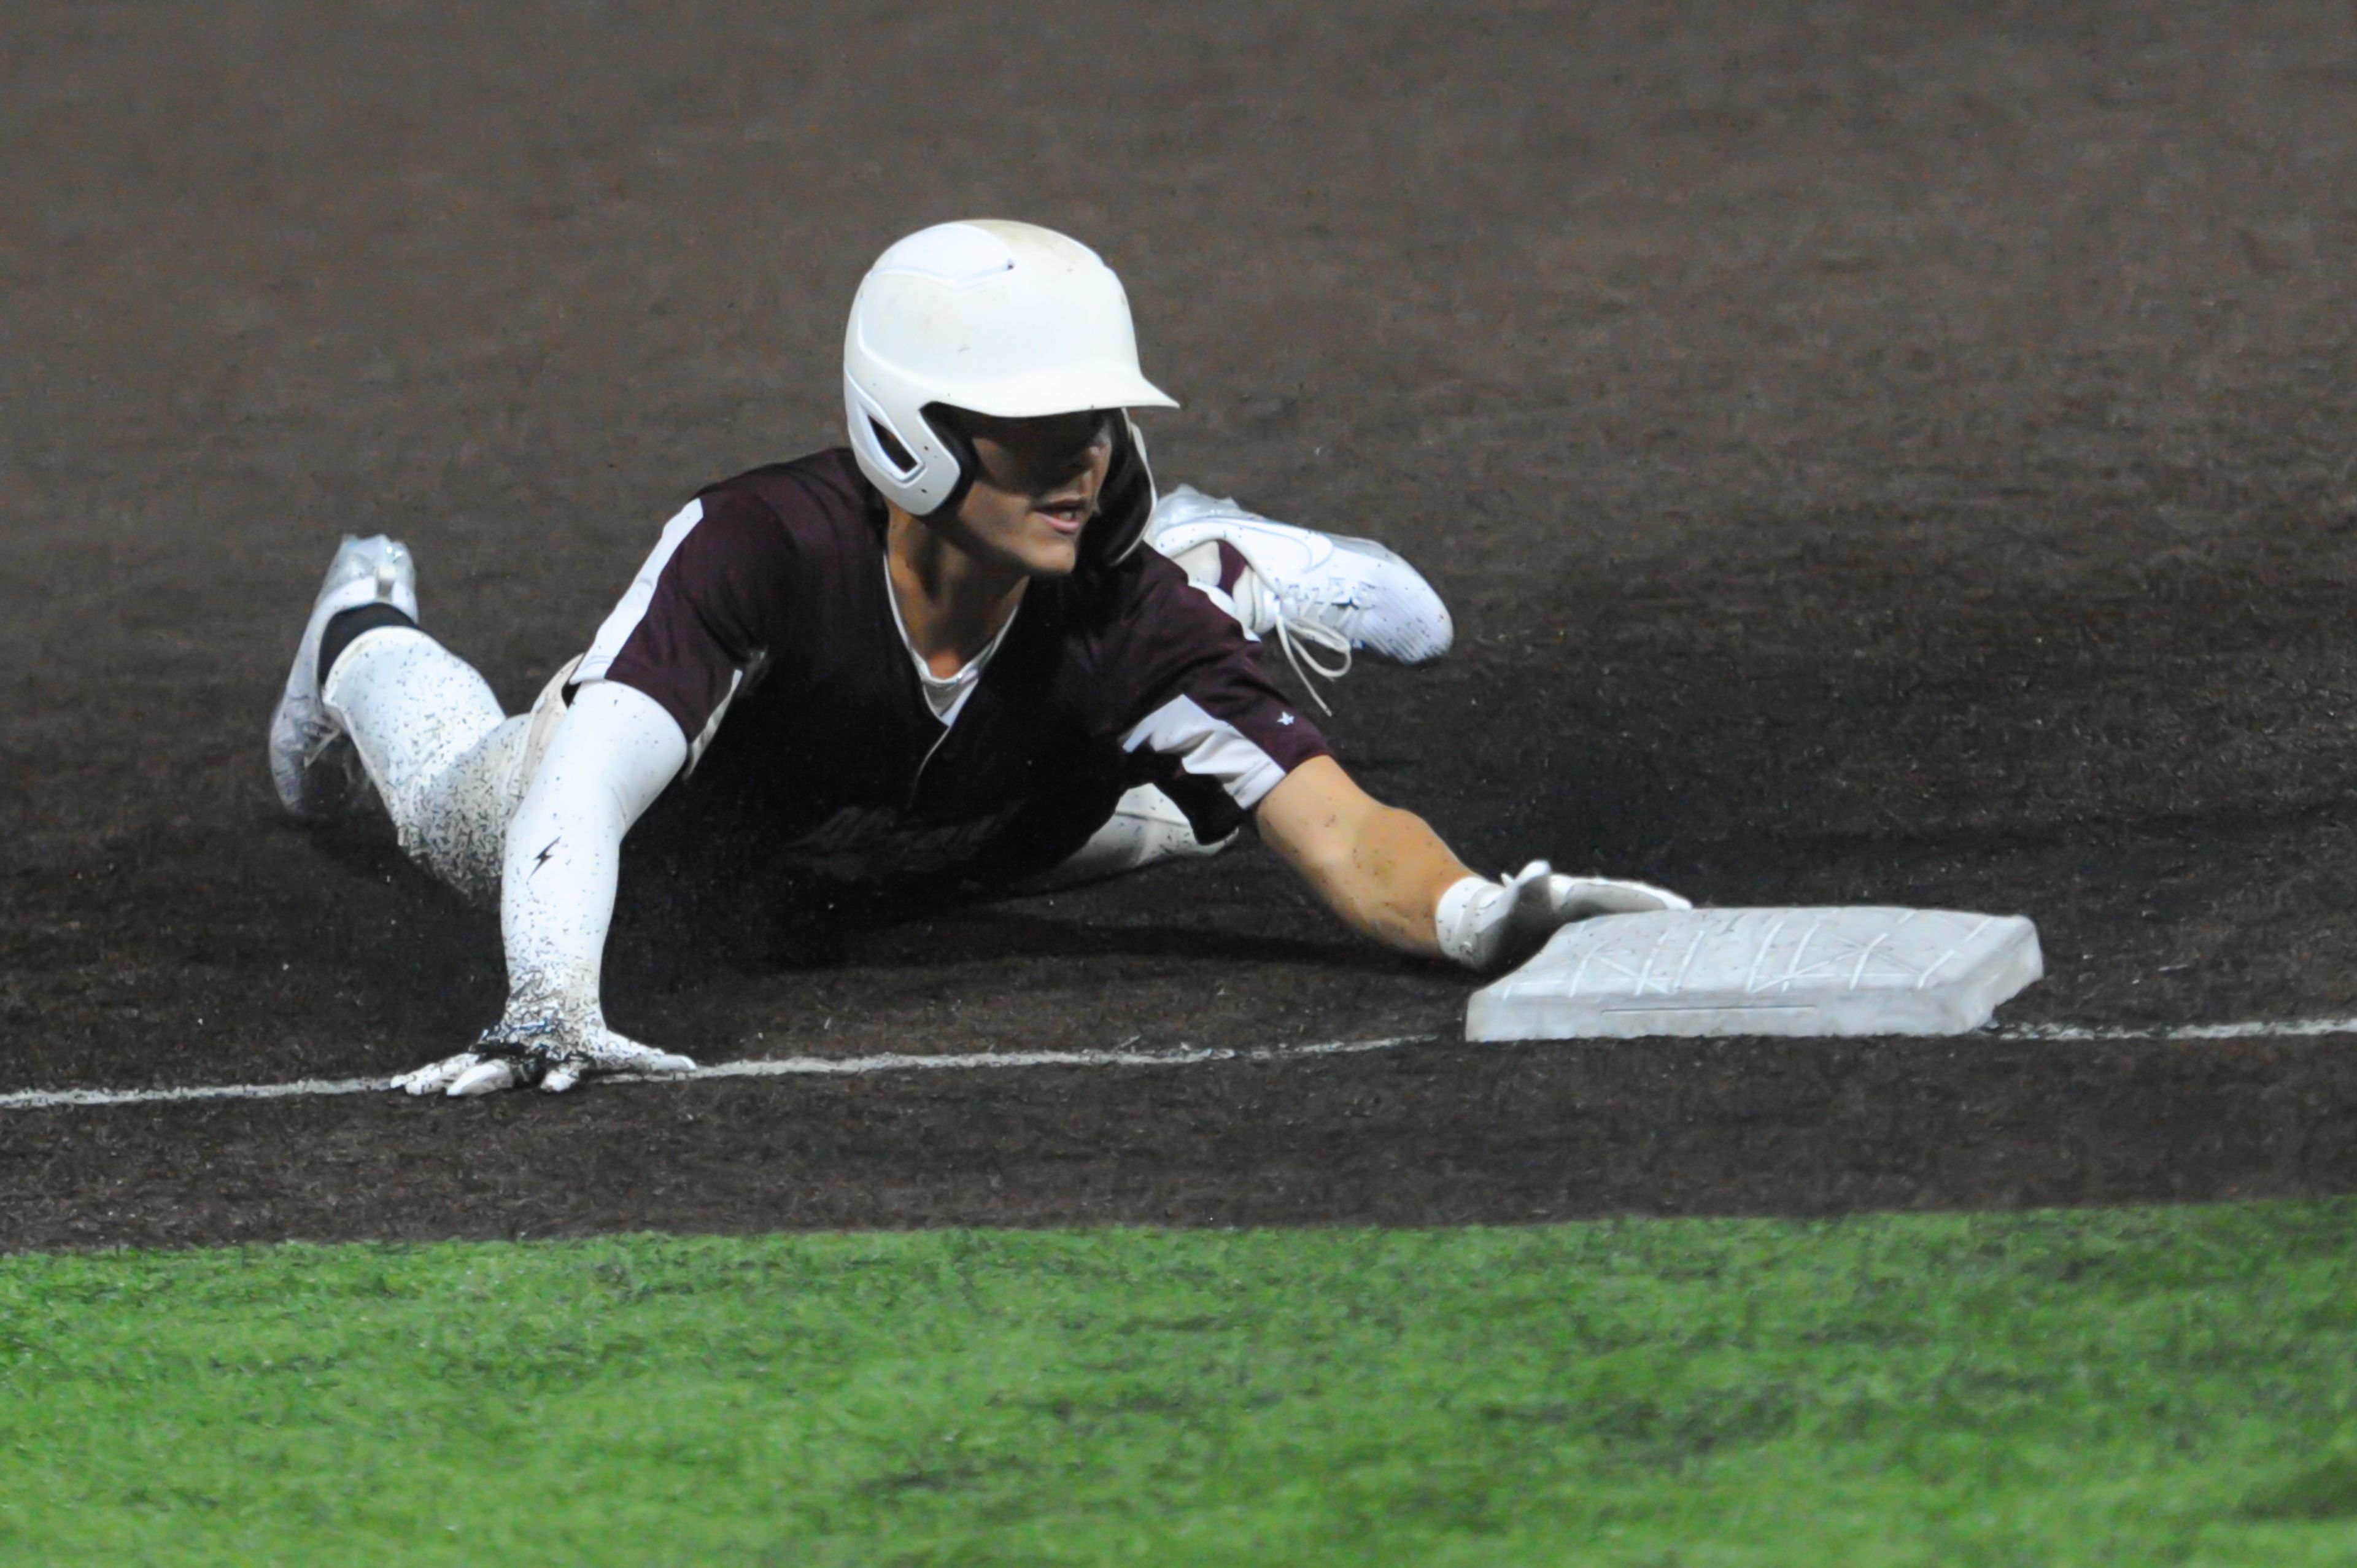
<box><xmin>938</xmin><ymin>412</ymin><xmax>1120</xmax><ymax>577</ymax></box>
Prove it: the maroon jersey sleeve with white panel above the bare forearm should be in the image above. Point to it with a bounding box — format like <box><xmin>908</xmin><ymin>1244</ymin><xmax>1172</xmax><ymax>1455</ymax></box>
<box><xmin>1108</xmin><ymin>557</ymin><xmax>1329</xmax><ymax>844</ymax></box>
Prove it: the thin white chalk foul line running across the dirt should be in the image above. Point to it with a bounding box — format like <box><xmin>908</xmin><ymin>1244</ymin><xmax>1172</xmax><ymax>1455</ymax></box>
<box><xmin>14</xmin><ymin>1019</ymin><xmax>2357</xmax><ymax>1111</ymax></box>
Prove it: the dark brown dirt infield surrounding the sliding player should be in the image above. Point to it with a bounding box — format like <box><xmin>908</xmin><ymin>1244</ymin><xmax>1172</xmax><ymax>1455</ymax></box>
<box><xmin>0</xmin><ymin>2</ymin><xmax>2357</xmax><ymax>1247</ymax></box>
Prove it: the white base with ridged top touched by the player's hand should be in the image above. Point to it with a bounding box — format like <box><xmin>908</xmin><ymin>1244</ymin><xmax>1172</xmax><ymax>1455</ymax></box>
<box><xmin>1466</xmin><ymin>905</ymin><xmax>2046</xmax><ymax>1040</ymax></box>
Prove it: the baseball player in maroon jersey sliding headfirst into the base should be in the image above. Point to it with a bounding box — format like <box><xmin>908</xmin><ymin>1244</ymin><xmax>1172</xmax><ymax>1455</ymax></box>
<box><xmin>271</xmin><ymin>222</ymin><xmax>1686</xmax><ymax>1094</ymax></box>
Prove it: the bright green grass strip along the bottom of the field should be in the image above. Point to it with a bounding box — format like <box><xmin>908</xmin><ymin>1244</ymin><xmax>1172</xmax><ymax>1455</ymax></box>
<box><xmin>0</xmin><ymin>1202</ymin><xmax>2357</xmax><ymax>1568</ymax></box>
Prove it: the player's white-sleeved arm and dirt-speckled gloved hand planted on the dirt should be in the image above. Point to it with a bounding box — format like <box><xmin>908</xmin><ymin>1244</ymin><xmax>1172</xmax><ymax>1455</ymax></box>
<box><xmin>396</xmin><ymin>681</ymin><xmax>695</xmax><ymax>1094</ymax></box>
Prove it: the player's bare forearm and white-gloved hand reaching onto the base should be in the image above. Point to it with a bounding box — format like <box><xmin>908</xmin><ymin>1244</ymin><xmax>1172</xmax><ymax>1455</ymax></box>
<box><xmin>1256</xmin><ymin>757</ymin><xmax>1687</xmax><ymax>969</ymax></box>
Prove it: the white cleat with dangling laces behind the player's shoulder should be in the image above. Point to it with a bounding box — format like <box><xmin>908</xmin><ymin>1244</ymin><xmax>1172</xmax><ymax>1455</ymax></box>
<box><xmin>1145</xmin><ymin>485</ymin><xmax>1457</xmax><ymax>698</ymax></box>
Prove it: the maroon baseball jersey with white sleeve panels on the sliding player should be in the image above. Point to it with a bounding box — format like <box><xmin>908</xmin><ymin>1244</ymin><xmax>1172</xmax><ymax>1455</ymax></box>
<box><xmin>575</xmin><ymin>450</ymin><xmax>1327</xmax><ymax>882</ymax></box>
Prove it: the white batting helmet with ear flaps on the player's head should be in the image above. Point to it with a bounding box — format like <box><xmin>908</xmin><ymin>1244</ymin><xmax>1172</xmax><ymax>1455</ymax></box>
<box><xmin>844</xmin><ymin>219</ymin><xmax>1178</xmax><ymax>561</ymax></box>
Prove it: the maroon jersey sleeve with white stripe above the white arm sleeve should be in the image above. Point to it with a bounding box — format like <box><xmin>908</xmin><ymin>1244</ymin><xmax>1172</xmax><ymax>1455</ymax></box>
<box><xmin>573</xmin><ymin>490</ymin><xmax>797</xmax><ymax>769</ymax></box>
